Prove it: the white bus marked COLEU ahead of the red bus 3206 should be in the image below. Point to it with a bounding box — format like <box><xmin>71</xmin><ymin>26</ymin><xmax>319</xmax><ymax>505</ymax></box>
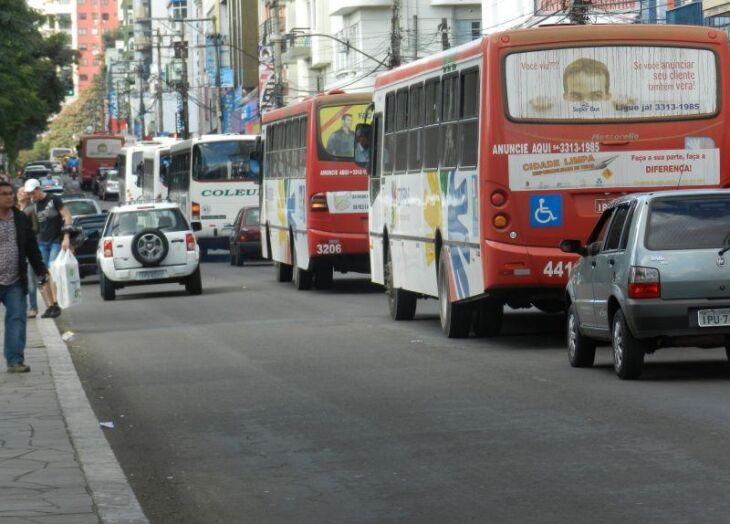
<box><xmin>168</xmin><ymin>135</ymin><xmax>261</xmax><ymax>254</ymax></box>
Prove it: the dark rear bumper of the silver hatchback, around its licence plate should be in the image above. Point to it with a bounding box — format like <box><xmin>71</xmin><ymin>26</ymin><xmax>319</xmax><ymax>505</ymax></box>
<box><xmin>622</xmin><ymin>299</ymin><xmax>730</xmax><ymax>346</ymax></box>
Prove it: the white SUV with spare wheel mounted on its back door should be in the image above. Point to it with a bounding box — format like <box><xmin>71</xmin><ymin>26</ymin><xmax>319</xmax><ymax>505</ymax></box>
<box><xmin>96</xmin><ymin>203</ymin><xmax>203</xmax><ymax>300</ymax></box>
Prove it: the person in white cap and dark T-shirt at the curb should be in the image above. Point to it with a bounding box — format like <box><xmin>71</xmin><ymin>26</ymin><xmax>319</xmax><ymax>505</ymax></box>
<box><xmin>24</xmin><ymin>178</ymin><xmax>73</xmax><ymax>318</ymax></box>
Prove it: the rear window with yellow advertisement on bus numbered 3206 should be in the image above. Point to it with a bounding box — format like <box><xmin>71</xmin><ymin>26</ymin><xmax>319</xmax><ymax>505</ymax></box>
<box><xmin>319</xmin><ymin>104</ymin><xmax>368</xmax><ymax>160</ymax></box>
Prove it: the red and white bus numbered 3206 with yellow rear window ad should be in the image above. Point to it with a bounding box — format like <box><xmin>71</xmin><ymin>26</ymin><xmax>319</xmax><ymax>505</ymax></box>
<box><xmin>260</xmin><ymin>92</ymin><xmax>372</xmax><ymax>289</ymax></box>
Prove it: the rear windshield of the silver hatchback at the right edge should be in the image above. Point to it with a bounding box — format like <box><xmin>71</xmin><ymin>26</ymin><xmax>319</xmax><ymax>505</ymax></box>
<box><xmin>646</xmin><ymin>196</ymin><xmax>730</xmax><ymax>251</ymax></box>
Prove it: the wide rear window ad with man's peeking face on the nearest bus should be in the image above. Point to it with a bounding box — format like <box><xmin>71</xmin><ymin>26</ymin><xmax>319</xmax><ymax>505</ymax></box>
<box><xmin>504</xmin><ymin>46</ymin><xmax>719</xmax><ymax>123</ymax></box>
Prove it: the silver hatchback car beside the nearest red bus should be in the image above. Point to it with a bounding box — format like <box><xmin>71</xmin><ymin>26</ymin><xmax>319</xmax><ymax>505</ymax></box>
<box><xmin>560</xmin><ymin>190</ymin><xmax>730</xmax><ymax>379</ymax></box>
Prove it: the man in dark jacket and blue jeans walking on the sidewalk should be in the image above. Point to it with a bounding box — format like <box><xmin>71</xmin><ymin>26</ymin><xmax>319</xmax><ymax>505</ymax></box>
<box><xmin>0</xmin><ymin>182</ymin><xmax>48</xmax><ymax>373</ymax></box>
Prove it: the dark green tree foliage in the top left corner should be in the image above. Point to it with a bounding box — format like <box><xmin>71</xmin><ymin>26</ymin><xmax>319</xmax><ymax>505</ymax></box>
<box><xmin>0</xmin><ymin>0</ymin><xmax>77</xmax><ymax>166</ymax></box>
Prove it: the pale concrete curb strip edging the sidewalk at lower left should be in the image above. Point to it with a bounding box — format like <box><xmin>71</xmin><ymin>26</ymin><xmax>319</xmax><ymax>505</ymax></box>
<box><xmin>37</xmin><ymin>319</ymin><xmax>149</xmax><ymax>524</ymax></box>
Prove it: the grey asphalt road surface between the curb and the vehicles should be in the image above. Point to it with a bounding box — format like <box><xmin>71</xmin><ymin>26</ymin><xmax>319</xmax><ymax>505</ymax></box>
<box><xmin>52</xmin><ymin>236</ymin><xmax>730</xmax><ymax>523</ymax></box>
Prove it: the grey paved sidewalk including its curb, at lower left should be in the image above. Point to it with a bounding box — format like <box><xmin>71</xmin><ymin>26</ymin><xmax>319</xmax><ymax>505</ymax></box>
<box><xmin>0</xmin><ymin>318</ymin><xmax>147</xmax><ymax>524</ymax></box>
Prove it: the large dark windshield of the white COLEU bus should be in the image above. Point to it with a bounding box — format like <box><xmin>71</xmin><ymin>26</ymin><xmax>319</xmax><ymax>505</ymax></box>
<box><xmin>193</xmin><ymin>140</ymin><xmax>259</xmax><ymax>182</ymax></box>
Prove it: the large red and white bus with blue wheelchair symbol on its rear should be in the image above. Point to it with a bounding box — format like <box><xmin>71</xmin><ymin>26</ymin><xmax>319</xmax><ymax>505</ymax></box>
<box><xmin>363</xmin><ymin>25</ymin><xmax>730</xmax><ymax>337</ymax></box>
